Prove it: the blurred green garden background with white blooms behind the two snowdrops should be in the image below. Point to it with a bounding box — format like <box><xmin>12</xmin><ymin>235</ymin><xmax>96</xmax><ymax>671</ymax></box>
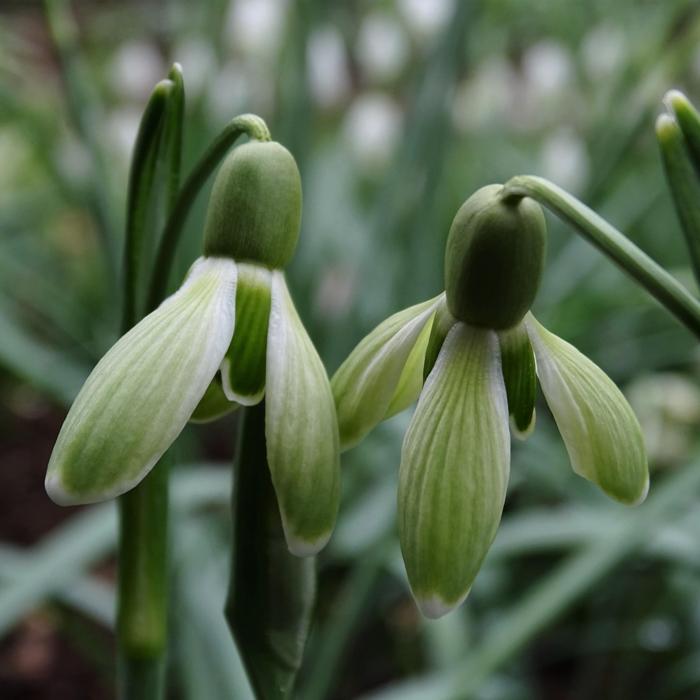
<box><xmin>0</xmin><ymin>0</ymin><xmax>700</xmax><ymax>700</ymax></box>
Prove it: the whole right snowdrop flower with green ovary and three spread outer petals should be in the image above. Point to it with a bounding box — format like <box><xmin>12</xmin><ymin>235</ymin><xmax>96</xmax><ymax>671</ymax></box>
<box><xmin>331</xmin><ymin>185</ymin><xmax>649</xmax><ymax>617</ymax></box>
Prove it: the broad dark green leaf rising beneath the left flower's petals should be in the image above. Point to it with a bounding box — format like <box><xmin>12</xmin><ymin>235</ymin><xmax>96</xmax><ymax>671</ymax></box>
<box><xmin>225</xmin><ymin>402</ymin><xmax>316</xmax><ymax>700</ymax></box>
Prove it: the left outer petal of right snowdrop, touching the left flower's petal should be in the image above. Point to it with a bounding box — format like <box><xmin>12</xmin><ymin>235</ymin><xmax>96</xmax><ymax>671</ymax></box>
<box><xmin>331</xmin><ymin>295</ymin><xmax>444</xmax><ymax>449</ymax></box>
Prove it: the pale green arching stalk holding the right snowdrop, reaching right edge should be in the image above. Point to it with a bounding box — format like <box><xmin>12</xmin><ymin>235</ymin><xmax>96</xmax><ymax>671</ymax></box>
<box><xmin>503</xmin><ymin>175</ymin><xmax>700</xmax><ymax>338</ymax></box>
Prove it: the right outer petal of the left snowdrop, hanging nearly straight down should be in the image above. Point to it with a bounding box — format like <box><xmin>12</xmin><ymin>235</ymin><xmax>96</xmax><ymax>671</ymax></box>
<box><xmin>265</xmin><ymin>270</ymin><xmax>340</xmax><ymax>556</ymax></box>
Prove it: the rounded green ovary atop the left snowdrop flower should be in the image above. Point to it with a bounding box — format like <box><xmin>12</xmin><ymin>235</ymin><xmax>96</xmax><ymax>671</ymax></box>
<box><xmin>204</xmin><ymin>141</ymin><xmax>301</xmax><ymax>268</ymax></box>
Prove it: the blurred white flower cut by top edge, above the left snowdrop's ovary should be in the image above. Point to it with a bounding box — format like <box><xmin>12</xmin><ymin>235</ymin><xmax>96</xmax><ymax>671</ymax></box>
<box><xmin>226</xmin><ymin>0</ymin><xmax>288</xmax><ymax>56</ymax></box>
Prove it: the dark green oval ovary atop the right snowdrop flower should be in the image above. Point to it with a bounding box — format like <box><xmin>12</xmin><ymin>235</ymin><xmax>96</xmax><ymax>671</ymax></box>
<box><xmin>445</xmin><ymin>185</ymin><xmax>547</xmax><ymax>330</ymax></box>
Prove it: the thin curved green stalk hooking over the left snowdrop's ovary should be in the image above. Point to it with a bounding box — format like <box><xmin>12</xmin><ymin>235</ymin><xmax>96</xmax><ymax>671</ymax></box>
<box><xmin>148</xmin><ymin>114</ymin><xmax>270</xmax><ymax>308</ymax></box>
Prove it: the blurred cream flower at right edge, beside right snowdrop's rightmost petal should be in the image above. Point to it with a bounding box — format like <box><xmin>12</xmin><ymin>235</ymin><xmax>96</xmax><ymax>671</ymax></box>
<box><xmin>627</xmin><ymin>372</ymin><xmax>700</xmax><ymax>466</ymax></box>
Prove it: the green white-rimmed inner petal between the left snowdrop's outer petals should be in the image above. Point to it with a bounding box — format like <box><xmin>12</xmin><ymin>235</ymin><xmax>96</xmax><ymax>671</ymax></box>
<box><xmin>221</xmin><ymin>263</ymin><xmax>272</xmax><ymax>406</ymax></box>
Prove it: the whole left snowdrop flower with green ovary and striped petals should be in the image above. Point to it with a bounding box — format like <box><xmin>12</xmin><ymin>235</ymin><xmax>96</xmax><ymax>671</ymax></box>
<box><xmin>46</xmin><ymin>141</ymin><xmax>339</xmax><ymax>555</ymax></box>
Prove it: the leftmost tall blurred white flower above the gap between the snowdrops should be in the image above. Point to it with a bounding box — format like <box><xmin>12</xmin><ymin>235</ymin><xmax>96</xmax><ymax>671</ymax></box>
<box><xmin>306</xmin><ymin>25</ymin><xmax>350</xmax><ymax>109</ymax></box>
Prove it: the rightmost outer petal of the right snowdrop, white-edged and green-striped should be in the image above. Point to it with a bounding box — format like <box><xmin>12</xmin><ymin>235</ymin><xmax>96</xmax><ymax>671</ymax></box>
<box><xmin>526</xmin><ymin>315</ymin><xmax>649</xmax><ymax>504</ymax></box>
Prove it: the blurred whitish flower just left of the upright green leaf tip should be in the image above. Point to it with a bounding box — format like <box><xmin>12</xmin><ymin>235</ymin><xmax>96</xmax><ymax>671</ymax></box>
<box><xmin>107</xmin><ymin>41</ymin><xmax>167</xmax><ymax>102</ymax></box>
